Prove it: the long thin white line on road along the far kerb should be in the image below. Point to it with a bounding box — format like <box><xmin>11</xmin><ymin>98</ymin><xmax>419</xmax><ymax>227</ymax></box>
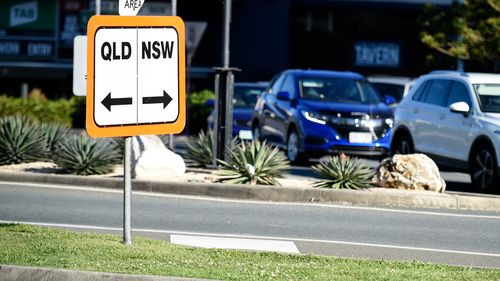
<box><xmin>0</xmin><ymin>181</ymin><xmax>500</xmax><ymax>220</ymax></box>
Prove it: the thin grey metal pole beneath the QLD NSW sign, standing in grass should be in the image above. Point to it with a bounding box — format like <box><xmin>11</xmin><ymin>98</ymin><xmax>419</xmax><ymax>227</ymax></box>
<box><xmin>123</xmin><ymin>137</ymin><xmax>132</xmax><ymax>245</ymax></box>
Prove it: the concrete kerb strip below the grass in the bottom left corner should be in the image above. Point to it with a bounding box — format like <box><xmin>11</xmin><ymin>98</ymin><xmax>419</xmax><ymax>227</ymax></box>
<box><xmin>0</xmin><ymin>265</ymin><xmax>215</xmax><ymax>281</ymax></box>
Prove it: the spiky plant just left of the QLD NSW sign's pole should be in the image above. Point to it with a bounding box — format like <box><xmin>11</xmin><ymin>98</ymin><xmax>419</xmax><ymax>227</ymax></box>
<box><xmin>54</xmin><ymin>135</ymin><xmax>119</xmax><ymax>175</ymax></box>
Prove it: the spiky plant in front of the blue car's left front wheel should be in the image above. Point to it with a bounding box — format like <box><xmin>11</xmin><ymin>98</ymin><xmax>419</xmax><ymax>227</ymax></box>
<box><xmin>216</xmin><ymin>141</ymin><xmax>290</xmax><ymax>185</ymax></box>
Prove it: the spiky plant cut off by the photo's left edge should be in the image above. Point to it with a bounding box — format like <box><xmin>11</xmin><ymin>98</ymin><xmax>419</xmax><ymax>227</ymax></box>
<box><xmin>0</xmin><ymin>116</ymin><xmax>48</xmax><ymax>165</ymax></box>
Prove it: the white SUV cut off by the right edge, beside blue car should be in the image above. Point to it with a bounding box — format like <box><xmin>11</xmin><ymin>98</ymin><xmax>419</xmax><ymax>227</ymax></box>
<box><xmin>391</xmin><ymin>71</ymin><xmax>500</xmax><ymax>191</ymax></box>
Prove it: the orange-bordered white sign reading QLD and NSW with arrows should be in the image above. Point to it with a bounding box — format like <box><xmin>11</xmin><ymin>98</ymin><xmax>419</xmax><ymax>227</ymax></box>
<box><xmin>86</xmin><ymin>16</ymin><xmax>186</xmax><ymax>137</ymax></box>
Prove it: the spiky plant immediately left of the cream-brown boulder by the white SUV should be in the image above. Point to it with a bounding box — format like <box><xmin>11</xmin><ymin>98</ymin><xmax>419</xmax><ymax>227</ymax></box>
<box><xmin>312</xmin><ymin>154</ymin><xmax>373</xmax><ymax>189</ymax></box>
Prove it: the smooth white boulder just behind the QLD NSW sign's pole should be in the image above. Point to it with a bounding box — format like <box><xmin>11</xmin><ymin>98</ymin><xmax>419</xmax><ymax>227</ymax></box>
<box><xmin>132</xmin><ymin>135</ymin><xmax>186</xmax><ymax>180</ymax></box>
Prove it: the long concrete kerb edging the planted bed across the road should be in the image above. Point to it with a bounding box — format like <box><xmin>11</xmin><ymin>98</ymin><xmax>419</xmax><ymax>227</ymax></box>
<box><xmin>0</xmin><ymin>172</ymin><xmax>500</xmax><ymax>212</ymax></box>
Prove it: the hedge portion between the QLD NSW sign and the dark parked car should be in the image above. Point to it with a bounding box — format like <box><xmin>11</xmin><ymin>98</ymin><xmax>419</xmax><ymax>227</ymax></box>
<box><xmin>188</xmin><ymin>90</ymin><xmax>215</xmax><ymax>133</ymax></box>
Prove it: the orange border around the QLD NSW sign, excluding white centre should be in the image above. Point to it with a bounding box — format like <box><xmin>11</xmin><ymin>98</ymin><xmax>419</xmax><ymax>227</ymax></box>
<box><xmin>86</xmin><ymin>16</ymin><xmax>186</xmax><ymax>138</ymax></box>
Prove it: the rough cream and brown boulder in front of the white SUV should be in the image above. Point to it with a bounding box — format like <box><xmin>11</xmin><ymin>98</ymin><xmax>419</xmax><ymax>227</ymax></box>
<box><xmin>373</xmin><ymin>154</ymin><xmax>446</xmax><ymax>192</ymax></box>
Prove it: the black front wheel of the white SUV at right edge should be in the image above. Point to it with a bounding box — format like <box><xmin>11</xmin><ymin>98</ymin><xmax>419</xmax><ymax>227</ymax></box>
<box><xmin>470</xmin><ymin>145</ymin><xmax>498</xmax><ymax>191</ymax></box>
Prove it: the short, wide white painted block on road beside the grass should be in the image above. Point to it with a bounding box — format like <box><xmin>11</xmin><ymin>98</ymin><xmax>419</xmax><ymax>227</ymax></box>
<box><xmin>170</xmin><ymin>234</ymin><xmax>299</xmax><ymax>254</ymax></box>
